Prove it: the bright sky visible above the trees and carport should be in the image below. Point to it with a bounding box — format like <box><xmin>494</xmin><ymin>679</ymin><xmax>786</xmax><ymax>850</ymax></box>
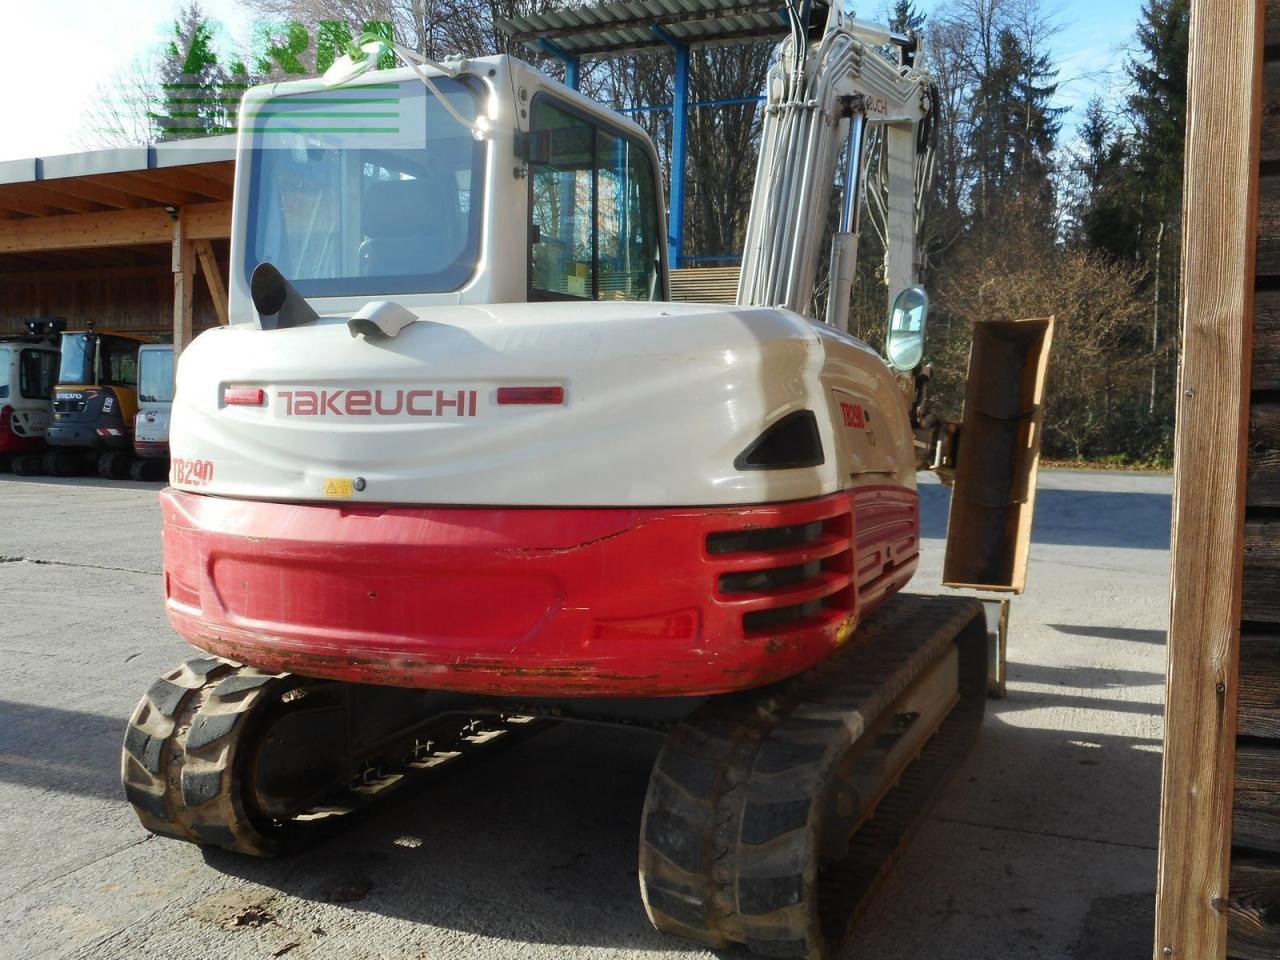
<box><xmin>0</xmin><ymin>0</ymin><xmax>1142</xmax><ymax>160</ymax></box>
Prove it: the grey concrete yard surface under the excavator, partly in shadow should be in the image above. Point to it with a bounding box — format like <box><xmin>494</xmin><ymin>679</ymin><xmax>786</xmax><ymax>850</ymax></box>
<box><xmin>0</xmin><ymin>471</ymin><xmax>1171</xmax><ymax>960</ymax></box>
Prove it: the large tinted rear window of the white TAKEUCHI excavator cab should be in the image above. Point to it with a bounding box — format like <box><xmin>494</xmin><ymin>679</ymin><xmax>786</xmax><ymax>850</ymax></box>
<box><xmin>244</xmin><ymin>77</ymin><xmax>485</xmax><ymax>297</ymax></box>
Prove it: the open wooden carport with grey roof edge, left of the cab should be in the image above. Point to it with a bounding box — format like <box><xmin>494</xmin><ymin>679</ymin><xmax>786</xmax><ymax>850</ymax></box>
<box><xmin>0</xmin><ymin>137</ymin><xmax>236</xmax><ymax>351</ymax></box>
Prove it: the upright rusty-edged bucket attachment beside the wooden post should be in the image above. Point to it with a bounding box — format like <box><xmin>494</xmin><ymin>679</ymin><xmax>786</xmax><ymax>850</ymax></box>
<box><xmin>942</xmin><ymin>317</ymin><xmax>1053</xmax><ymax>594</ymax></box>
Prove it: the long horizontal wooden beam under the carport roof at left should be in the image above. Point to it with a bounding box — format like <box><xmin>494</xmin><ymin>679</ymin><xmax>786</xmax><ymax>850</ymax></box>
<box><xmin>0</xmin><ymin>202</ymin><xmax>232</xmax><ymax>253</ymax></box>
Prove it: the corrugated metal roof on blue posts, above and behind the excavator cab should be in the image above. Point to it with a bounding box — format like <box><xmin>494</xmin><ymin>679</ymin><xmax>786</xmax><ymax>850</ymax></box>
<box><xmin>498</xmin><ymin>0</ymin><xmax>788</xmax><ymax>58</ymax></box>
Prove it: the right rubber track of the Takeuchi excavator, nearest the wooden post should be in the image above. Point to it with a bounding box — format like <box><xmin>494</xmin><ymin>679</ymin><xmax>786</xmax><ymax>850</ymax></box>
<box><xmin>640</xmin><ymin>595</ymin><xmax>986</xmax><ymax>959</ymax></box>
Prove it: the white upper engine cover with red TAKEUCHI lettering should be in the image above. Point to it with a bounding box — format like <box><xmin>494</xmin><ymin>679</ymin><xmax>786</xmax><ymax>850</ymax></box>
<box><xmin>170</xmin><ymin>302</ymin><xmax>915</xmax><ymax>507</ymax></box>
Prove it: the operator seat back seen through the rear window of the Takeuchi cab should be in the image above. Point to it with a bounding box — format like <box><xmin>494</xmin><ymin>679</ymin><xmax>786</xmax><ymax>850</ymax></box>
<box><xmin>360</xmin><ymin>170</ymin><xmax>465</xmax><ymax>276</ymax></box>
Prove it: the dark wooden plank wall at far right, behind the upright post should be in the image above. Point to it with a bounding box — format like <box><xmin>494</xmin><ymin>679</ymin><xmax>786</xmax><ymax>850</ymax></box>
<box><xmin>1228</xmin><ymin>0</ymin><xmax>1280</xmax><ymax>960</ymax></box>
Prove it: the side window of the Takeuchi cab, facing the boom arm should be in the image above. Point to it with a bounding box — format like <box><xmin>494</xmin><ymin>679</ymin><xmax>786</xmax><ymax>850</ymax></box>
<box><xmin>529</xmin><ymin>97</ymin><xmax>663</xmax><ymax>300</ymax></box>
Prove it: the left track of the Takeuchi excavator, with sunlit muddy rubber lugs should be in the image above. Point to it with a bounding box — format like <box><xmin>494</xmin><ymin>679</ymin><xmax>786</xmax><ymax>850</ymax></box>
<box><xmin>120</xmin><ymin>657</ymin><xmax>541</xmax><ymax>856</ymax></box>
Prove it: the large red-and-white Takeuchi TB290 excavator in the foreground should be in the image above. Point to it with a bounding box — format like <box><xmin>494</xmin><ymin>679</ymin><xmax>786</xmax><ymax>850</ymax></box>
<box><xmin>122</xmin><ymin>3</ymin><xmax>1051</xmax><ymax>957</ymax></box>
